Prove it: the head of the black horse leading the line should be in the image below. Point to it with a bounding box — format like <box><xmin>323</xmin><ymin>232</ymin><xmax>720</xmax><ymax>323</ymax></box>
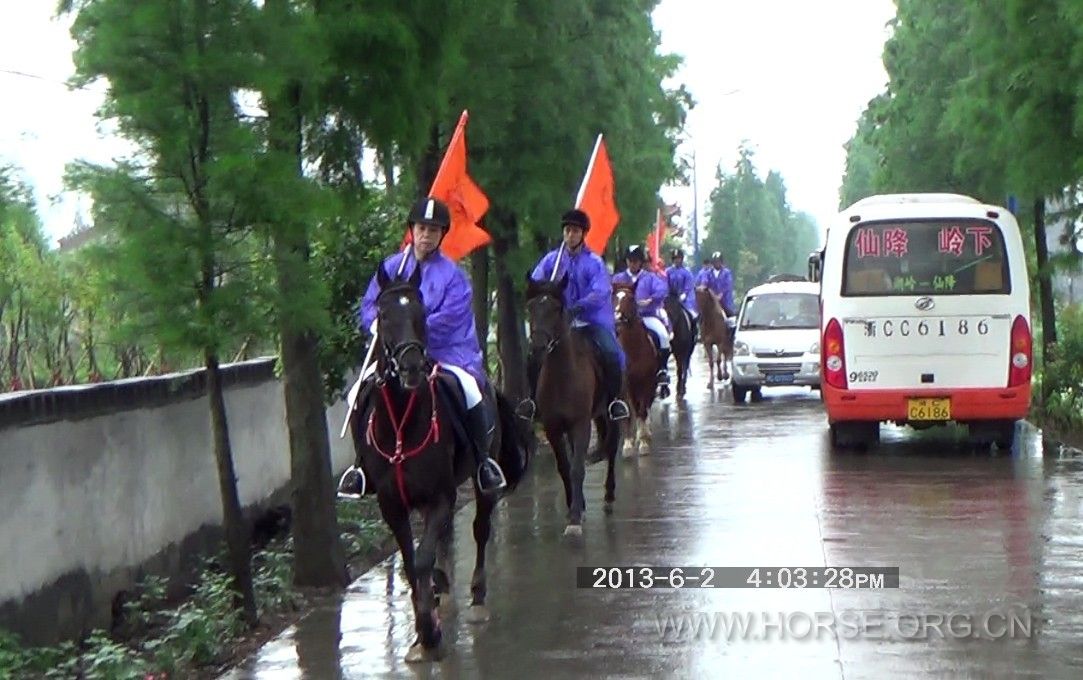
<box><xmin>376</xmin><ymin>265</ymin><xmax>431</xmax><ymax>390</ymax></box>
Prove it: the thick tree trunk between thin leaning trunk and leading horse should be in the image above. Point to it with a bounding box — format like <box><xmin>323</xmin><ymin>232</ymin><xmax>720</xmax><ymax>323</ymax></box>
<box><xmin>264</xmin><ymin>19</ymin><xmax>350</xmax><ymax>588</ymax></box>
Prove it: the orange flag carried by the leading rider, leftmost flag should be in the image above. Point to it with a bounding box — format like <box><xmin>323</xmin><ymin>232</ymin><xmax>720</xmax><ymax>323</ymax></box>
<box><xmin>403</xmin><ymin>110</ymin><xmax>493</xmax><ymax>262</ymax></box>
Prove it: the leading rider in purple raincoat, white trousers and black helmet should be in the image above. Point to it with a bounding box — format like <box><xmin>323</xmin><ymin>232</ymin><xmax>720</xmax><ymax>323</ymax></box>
<box><xmin>348</xmin><ymin>198</ymin><xmax>507</xmax><ymax>493</ymax></box>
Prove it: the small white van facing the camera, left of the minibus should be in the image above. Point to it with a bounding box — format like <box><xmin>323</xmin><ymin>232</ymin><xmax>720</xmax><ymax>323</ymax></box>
<box><xmin>731</xmin><ymin>280</ymin><xmax>820</xmax><ymax>404</ymax></box>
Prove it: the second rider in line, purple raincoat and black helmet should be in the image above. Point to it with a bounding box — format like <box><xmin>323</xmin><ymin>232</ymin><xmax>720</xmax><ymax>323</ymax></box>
<box><xmin>517</xmin><ymin>210</ymin><xmax>630</xmax><ymax>420</ymax></box>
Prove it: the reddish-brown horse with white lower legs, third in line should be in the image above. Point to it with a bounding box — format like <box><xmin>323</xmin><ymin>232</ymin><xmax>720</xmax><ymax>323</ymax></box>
<box><xmin>613</xmin><ymin>284</ymin><xmax>658</xmax><ymax>456</ymax></box>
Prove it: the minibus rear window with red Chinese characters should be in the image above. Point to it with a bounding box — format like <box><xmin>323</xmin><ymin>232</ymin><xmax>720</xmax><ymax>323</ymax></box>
<box><xmin>843</xmin><ymin>220</ymin><xmax>1012</xmax><ymax>296</ymax></box>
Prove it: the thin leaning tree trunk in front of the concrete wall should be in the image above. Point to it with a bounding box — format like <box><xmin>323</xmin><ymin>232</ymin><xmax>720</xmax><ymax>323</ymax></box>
<box><xmin>204</xmin><ymin>349</ymin><xmax>259</xmax><ymax>628</ymax></box>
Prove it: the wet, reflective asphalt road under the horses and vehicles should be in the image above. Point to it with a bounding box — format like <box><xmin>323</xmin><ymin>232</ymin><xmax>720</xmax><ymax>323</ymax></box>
<box><xmin>225</xmin><ymin>355</ymin><xmax>1083</xmax><ymax>680</ymax></box>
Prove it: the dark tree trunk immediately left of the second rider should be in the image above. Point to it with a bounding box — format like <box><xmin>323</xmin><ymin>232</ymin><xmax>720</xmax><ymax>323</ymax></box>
<box><xmin>493</xmin><ymin>214</ymin><xmax>527</xmax><ymax>402</ymax></box>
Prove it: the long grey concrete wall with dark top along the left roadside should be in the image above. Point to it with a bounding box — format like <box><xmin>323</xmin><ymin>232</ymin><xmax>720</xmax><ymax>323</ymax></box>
<box><xmin>0</xmin><ymin>358</ymin><xmax>353</xmax><ymax>642</ymax></box>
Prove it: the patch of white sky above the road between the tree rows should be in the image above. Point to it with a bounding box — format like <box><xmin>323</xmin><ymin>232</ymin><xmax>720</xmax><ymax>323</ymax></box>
<box><xmin>649</xmin><ymin>0</ymin><xmax>895</xmax><ymax>246</ymax></box>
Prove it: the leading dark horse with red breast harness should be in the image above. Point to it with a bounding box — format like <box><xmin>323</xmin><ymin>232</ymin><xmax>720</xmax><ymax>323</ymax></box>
<box><xmin>351</xmin><ymin>267</ymin><xmax>526</xmax><ymax>662</ymax></box>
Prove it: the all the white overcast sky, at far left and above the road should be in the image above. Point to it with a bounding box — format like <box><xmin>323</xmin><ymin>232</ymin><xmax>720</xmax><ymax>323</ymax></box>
<box><xmin>0</xmin><ymin>0</ymin><xmax>895</xmax><ymax>250</ymax></box>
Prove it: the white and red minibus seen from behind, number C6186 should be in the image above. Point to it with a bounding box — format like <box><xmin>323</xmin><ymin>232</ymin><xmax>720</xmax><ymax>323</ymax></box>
<box><xmin>820</xmin><ymin>194</ymin><xmax>1032</xmax><ymax>448</ymax></box>
